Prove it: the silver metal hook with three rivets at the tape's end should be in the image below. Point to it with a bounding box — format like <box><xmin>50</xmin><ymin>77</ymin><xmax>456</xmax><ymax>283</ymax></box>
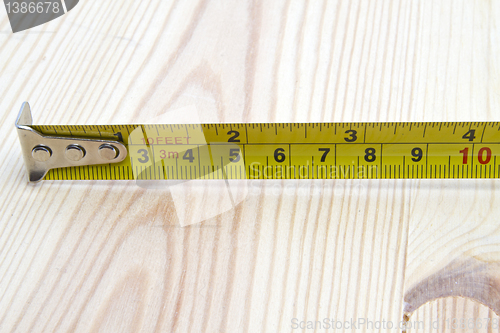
<box><xmin>16</xmin><ymin>102</ymin><xmax>127</xmax><ymax>182</ymax></box>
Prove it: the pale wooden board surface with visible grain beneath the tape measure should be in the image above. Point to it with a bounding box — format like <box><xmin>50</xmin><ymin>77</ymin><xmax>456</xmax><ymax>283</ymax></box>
<box><xmin>0</xmin><ymin>0</ymin><xmax>500</xmax><ymax>332</ymax></box>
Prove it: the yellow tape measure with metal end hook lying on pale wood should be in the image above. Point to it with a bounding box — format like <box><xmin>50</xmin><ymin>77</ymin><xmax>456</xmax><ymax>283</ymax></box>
<box><xmin>16</xmin><ymin>103</ymin><xmax>500</xmax><ymax>181</ymax></box>
